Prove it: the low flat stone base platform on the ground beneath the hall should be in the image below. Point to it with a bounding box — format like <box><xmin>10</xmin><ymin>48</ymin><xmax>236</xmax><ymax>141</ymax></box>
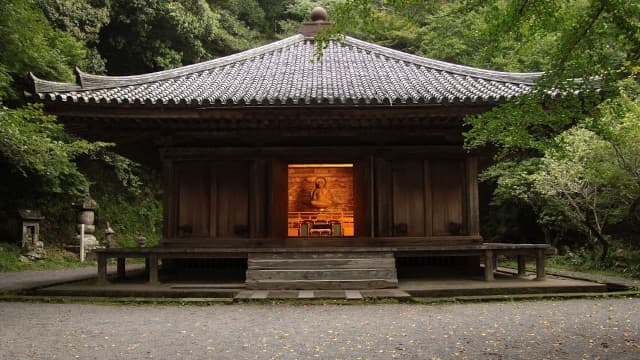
<box><xmin>33</xmin><ymin>272</ymin><xmax>607</xmax><ymax>301</ymax></box>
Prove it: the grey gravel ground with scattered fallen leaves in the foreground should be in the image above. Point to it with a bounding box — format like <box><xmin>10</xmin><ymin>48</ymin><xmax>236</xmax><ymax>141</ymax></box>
<box><xmin>0</xmin><ymin>298</ymin><xmax>640</xmax><ymax>359</ymax></box>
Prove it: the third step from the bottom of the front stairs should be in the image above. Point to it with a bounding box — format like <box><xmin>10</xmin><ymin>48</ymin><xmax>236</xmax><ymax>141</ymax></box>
<box><xmin>248</xmin><ymin>258</ymin><xmax>395</xmax><ymax>270</ymax></box>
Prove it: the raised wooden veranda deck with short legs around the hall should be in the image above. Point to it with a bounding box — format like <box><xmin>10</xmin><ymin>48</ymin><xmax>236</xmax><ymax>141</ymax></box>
<box><xmin>95</xmin><ymin>243</ymin><xmax>555</xmax><ymax>285</ymax></box>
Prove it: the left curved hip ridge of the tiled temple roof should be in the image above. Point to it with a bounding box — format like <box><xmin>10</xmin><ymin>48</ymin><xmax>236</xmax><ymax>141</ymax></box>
<box><xmin>76</xmin><ymin>34</ymin><xmax>305</xmax><ymax>90</ymax></box>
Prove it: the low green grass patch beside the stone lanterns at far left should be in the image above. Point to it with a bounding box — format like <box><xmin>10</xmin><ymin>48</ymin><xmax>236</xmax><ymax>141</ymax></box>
<box><xmin>0</xmin><ymin>243</ymin><xmax>96</xmax><ymax>272</ymax></box>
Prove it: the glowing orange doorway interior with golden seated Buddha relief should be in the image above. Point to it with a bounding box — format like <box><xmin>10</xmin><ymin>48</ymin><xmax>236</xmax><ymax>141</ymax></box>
<box><xmin>288</xmin><ymin>164</ymin><xmax>354</xmax><ymax>237</ymax></box>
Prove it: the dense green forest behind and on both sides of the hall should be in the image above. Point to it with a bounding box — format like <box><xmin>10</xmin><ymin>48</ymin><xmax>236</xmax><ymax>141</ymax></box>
<box><xmin>0</xmin><ymin>0</ymin><xmax>640</xmax><ymax>275</ymax></box>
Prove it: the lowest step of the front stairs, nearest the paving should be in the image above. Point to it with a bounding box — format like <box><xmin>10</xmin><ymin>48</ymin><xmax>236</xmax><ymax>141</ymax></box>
<box><xmin>247</xmin><ymin>279</ymin><xmax>398</xmax><ymax>290</ymax></box>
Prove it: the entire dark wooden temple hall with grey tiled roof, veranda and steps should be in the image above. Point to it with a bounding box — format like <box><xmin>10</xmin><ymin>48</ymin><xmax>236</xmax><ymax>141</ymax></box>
<box><xmin>32</xmin><ymin>9</ymin><xmax>548</xmax><ymax>289</ymax></box>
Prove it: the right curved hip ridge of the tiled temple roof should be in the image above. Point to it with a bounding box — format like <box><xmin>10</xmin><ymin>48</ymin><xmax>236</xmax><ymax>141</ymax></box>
<box><xmin>345</xmin><ymin>36</ymin><xmax>544</xmax><ymax>85</ymax></box>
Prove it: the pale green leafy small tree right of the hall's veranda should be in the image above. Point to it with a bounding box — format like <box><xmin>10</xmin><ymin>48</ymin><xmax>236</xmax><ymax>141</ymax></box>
<box><xmin>524</xmin><ymin>81</ymin><xmax>640</xmax><ymax>261</ymax></box>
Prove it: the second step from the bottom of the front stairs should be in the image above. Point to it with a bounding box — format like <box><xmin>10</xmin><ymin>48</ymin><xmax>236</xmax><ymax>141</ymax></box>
<box><xmin>247</xmin><ymin>268</ymin><xmax>397</xmax><ymax>280</ymax></box>
